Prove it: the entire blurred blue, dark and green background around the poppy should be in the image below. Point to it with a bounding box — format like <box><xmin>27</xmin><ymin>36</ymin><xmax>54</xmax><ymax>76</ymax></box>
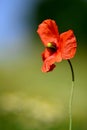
<box><xmin>0</xmin><ymin>0</ymin><xmax>87</xmax><ymax>130</ymax></box>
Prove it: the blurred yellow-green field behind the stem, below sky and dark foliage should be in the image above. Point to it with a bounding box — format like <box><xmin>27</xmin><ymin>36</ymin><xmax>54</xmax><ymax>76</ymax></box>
<box><xmin>0</xmin><ymin>41</ymin><xmax>87</xmax><ymax>130</ymax></box>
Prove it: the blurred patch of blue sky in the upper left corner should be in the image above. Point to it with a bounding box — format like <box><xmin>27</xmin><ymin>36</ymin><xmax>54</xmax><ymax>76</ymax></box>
<box><xmin>0</xmin><ymin>0</ymin><xmax>40</xmax><ymax>59</ymax></box>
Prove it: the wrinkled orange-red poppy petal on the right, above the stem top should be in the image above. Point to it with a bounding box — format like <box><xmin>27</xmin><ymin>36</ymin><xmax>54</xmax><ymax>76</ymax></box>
<box><xmin>60</xmin><ymin>30</ymin><xmax>77</xmax><ymax>59</ymax></box>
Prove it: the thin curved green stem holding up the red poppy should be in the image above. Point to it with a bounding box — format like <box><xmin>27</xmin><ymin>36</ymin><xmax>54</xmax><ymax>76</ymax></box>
<box><xmin>68</xmin><ymin>60</ymin><xmax>75</xmax><ymax>130</ymax></box>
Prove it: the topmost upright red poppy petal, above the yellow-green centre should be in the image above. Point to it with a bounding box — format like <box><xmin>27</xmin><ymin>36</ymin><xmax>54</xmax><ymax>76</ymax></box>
<box><xmin>37</xmin><ymin>19</ymin><xmax>59</xmax><ymax>46</ymax></box>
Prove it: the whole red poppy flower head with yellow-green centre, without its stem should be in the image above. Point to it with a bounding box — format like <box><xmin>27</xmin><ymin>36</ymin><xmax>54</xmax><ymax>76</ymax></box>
<box><xmin>37</xmin><ymin>19</ymin><xmax>77</xmax><ymax>72</ymax></box>
